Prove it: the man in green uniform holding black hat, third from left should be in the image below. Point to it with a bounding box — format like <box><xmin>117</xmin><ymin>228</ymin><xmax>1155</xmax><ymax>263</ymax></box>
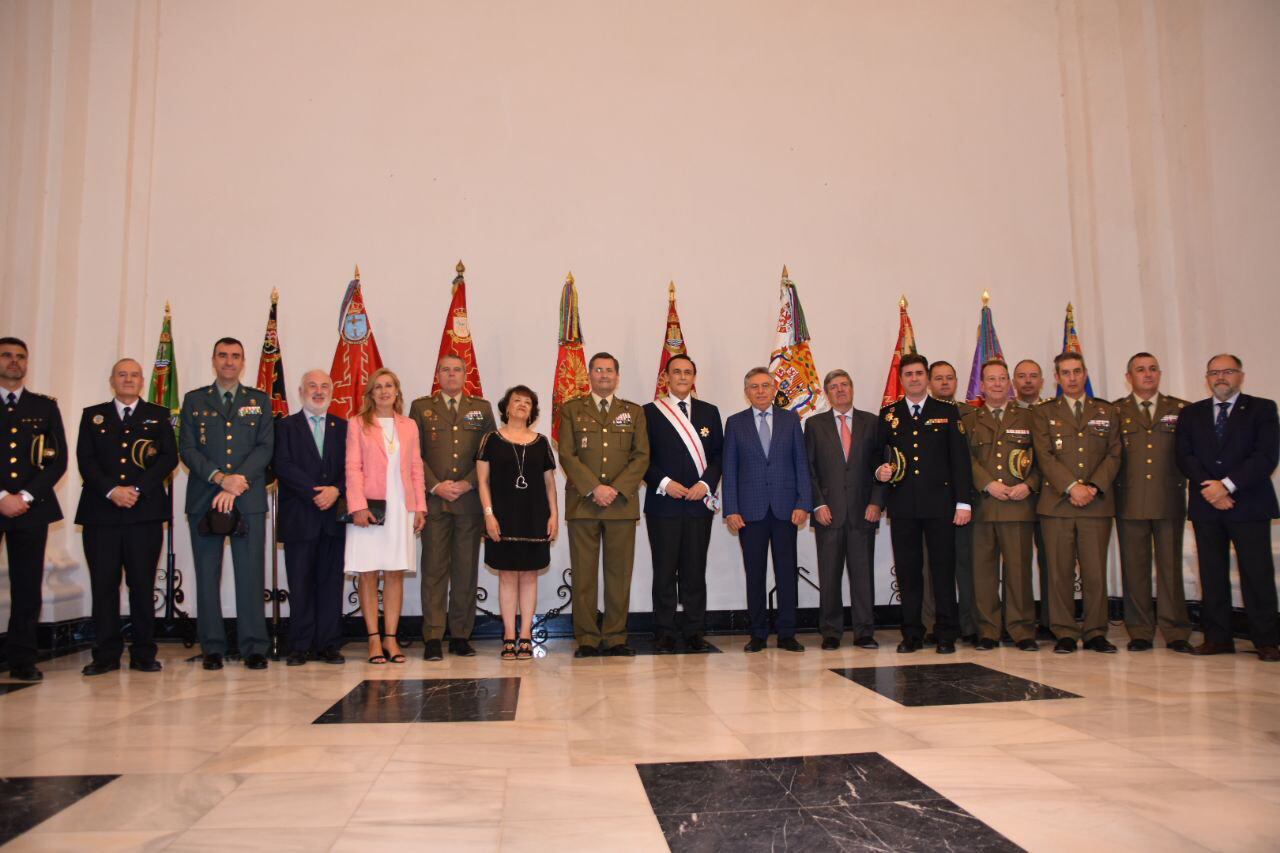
<box><xmin>179</xmin><ymin>338</ymin><xmax>275</xmax><ymax>670</ymax></box>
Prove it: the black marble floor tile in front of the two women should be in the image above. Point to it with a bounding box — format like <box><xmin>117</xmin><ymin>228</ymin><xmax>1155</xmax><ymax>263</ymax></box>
<box><xmin>314</xmin><ymin>678</ymin><xmax>520</xmax><ymax>724</ymax></box>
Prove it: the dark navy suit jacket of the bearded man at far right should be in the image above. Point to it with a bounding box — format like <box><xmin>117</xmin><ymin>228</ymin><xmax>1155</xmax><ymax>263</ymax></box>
<box><xmin>1178</xmin><ymin>394</ymin><xmax>1280</xmax><ymax>521</ymax></box>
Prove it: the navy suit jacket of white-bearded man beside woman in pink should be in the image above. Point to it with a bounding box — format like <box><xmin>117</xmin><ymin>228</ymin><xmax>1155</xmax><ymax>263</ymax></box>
<box><xmin>271</xmin><ymin>410</ymin><xmax>348</xmax><ymax>542</ymax></box>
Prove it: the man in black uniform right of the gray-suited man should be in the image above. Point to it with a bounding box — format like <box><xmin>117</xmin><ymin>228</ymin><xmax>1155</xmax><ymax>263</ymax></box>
<box><xmin>872</xmin><ymin>355</ymin><xmax>973</xmax><ymax>654</ymax></box>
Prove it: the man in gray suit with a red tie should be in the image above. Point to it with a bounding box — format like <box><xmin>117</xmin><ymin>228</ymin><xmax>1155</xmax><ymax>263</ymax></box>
<box><xmin>804</xmin><ymin>370</ymin><xmax>884</xmax><ymax>649</ymax></box>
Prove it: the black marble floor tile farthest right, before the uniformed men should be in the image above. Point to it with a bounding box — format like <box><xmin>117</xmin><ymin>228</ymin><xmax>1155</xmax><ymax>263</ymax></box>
<box><xmin>832</xmin><ymin>663</ymin><xmax>1080</xmax><ymax>706</ymax></box>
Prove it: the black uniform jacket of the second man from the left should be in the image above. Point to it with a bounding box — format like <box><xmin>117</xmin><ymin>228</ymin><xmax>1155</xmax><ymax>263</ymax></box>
<box><xmin>76</xmin><ymin>400</ymin><xmax>178</xmax><ymax>525</ymax></box>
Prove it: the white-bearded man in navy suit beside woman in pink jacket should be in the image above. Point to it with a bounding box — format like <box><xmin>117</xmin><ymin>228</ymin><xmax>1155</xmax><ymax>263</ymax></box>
<box><xmin>271</xmin><ymin>370</ymin><xmax>347</xmax><ymax>666</ymax></box>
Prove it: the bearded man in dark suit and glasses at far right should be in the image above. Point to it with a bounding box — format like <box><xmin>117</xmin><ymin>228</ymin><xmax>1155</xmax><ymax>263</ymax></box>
<box><xmin>1176</xmin><ymin>353</ymin><xmax>1280</xmax><ymax>663</ymax></box>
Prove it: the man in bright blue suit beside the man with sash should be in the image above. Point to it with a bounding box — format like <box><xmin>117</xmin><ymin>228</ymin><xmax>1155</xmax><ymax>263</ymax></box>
<box><xmin>723</xmin><ymin>368</ymin><xmax>813</xmax><ymax>653</ymax></box>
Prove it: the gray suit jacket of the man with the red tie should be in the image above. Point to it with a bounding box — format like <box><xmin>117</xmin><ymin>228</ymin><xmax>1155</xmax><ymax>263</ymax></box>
<box><xmin>804</xmin><ymin>409</ymin><xmax>884</xmax><ymax>530</ymax></box>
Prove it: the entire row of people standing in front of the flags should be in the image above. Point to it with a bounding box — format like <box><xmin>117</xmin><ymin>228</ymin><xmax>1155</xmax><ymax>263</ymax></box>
<box><xmin>0</xmin><ymin>337</ymin><xmax>1280</xmax><ymax>681</ymax></box>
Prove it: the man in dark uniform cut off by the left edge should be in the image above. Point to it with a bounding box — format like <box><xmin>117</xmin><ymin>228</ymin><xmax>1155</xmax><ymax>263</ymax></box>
<box><xmin>0</xmin><ymin>337</ymin><xmax>67</xmax><ymax>681</ymax></box>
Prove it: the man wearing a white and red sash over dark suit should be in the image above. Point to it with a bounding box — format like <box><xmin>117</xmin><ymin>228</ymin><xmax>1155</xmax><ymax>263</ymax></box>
<box><xmin>644</xmin><ymin>355</ymin><xmax>724</xmax><ymax>653</ymax></box>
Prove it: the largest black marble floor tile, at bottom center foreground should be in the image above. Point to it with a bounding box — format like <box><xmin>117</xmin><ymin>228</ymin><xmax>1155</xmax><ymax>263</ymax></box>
<box><xmin>636</xmin><ymin>753</ymin><xmax>1020</xmax><ymax>853</ymax></box>
